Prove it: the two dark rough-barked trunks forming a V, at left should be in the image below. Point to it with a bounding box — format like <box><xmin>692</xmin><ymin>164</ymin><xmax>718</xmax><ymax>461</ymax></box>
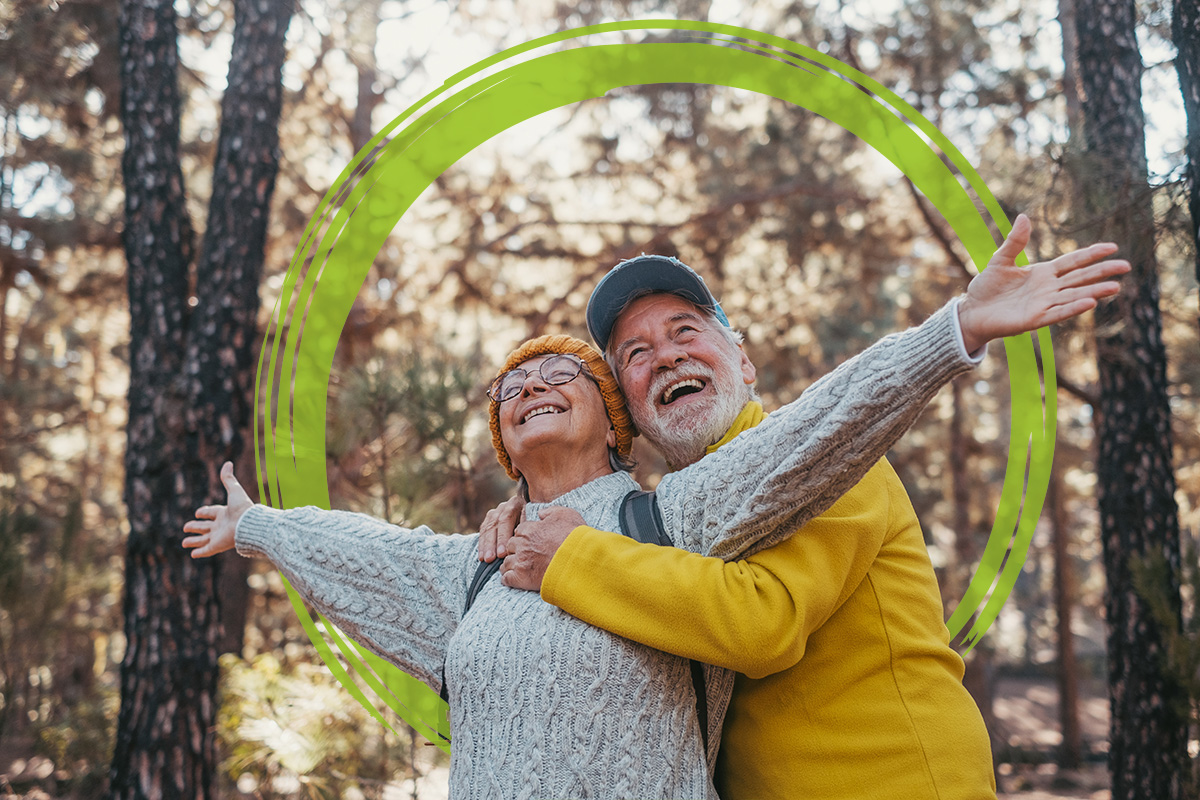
<box><xmin>109</xmin><ymin>0</ymin><xmax>292</xmax><ymax>798</ymax></box>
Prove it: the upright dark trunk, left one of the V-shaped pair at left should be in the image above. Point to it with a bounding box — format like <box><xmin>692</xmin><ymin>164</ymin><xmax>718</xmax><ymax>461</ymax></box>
<box><xmin>109</xmin><ymin>0</ymin><xmax>205</xmax><ymax>798</ymax></box>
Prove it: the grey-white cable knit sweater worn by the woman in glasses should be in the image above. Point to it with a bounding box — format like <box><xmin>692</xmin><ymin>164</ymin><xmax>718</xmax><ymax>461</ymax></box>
<box><xmin>236</xmin><ymin>297</ymin><xmax>974</xmax><ymax>800</ymax></box>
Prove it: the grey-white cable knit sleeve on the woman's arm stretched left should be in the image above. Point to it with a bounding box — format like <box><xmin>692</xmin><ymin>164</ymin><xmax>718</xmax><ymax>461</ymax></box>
<box><xmin>236</xmin><ymin>505</ymin><xmax>478</xmax><ymax>690</ymax></box>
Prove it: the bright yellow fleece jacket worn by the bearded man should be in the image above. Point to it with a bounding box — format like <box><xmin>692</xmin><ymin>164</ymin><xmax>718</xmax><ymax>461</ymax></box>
<box><xmin>541</xmin><ymin>403</ymin><xmax>996</xmax><ymax>800</ymax></box>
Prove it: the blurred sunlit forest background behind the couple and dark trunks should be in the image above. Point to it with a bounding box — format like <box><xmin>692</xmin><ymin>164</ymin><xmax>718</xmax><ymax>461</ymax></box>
<box><xmin>0</xmin><ymin>0</ymin><xmax>1200</xmax><ymax>798</ymax></box>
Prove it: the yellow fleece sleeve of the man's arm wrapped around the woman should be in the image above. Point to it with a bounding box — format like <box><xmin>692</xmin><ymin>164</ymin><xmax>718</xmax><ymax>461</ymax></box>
<box><xmin>541</xmin><ymin>462</ymin><xmax>894</xmax><ymax>678</ymax></box>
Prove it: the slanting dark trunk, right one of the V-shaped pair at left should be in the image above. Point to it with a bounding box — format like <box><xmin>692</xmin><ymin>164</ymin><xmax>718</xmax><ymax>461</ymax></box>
<box><xmin>186</xmin><ymin>0</ymin><xmax>292</xmax><ymax>654</ymax></box>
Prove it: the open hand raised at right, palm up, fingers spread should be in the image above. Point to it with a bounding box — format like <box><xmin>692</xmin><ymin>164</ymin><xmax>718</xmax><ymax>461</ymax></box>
<box><xmin>959</xmin><ymin>213</ymin><xmax>1129</xmax><ymax>353</ymax></box>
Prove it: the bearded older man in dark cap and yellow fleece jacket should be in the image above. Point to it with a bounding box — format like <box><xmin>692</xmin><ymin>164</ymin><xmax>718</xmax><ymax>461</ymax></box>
<box><xmin>480</xmin><ymin>216</ymin><xmax>1115</xmax><ymax>800</ymax></box>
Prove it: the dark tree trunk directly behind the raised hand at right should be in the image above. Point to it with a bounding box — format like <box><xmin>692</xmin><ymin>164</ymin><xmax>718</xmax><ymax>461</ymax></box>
<box><xmin>1076</xmin><ymin>0</ymin><xmax>1187</xmax><ymax>800</ymax></box>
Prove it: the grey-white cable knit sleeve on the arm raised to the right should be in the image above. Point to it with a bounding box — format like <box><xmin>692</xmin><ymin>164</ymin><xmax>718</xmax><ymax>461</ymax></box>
<box><xmin>658</xmin><ymin>301</ymin><xmax>977</xmax><ymax>561</ymax></box>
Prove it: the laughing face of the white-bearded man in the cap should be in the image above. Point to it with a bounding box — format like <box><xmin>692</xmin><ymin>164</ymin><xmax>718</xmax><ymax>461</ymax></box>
<box><xmin>611</xmin><ymin>294</ymin><xmax>755</xmax><ymax>467</ymax></box>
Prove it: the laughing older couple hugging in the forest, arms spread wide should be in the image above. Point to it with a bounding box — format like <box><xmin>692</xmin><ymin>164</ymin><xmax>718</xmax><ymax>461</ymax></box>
<box><xmin>182</xmin><ymin>215</ymin><xmax>1129</xmax><ymax>800</ymax></box>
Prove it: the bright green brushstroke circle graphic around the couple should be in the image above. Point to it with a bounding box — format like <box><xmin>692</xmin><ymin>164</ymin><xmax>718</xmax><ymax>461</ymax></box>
<box><xmin>254</xmin><ymin>20</ymin><xmax>1056</xmax><ymax>747</ymax></box>
